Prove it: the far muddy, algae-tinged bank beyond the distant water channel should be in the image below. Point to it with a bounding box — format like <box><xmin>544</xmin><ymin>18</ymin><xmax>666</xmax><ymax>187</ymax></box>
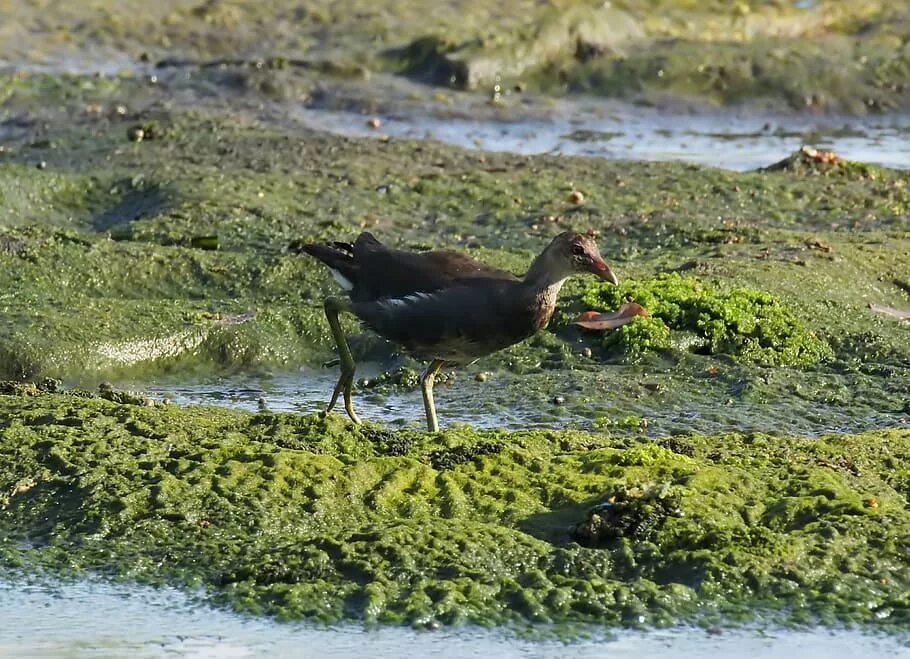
<box><xmin>0</xmin><ymin>0</ymin><xmax>910</xmax><ymax>114</ymax></box>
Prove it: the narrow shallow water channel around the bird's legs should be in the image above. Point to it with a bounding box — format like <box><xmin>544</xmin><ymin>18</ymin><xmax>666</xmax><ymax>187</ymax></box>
<box><xmin>114</xmin><ymin>363</ymin><xmax>910</xmax><ymax>436</ymax></box>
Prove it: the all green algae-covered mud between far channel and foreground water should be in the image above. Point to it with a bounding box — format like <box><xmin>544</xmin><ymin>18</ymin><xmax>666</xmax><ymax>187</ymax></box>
<box><xmin>0</xmin><ymin>76</ymin><xmax>910</xmax><ymax>629</ymax></box>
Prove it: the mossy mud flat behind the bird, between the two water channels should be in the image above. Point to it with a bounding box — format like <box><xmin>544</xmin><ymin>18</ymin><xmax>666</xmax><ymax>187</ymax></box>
<box><xmin>0</xmin><ymin>74</ymin><xmax>910</xmax><ymax>434</ymax></box>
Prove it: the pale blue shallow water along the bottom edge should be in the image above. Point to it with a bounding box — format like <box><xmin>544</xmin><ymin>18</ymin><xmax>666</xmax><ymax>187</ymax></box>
<box><xmin>0</xmin><ymin>578</ymin><xmax>910</xmax><ymax>659</ymax></box>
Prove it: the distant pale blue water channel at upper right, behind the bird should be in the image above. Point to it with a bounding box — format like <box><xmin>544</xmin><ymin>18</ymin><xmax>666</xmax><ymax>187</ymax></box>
<box><xmin>290</xmin><ymin>103</ymin><xmax>910</xmax><ymax>171</ymax></box>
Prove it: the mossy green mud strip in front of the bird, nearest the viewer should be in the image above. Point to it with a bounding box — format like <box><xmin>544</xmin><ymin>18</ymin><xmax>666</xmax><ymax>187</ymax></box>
<box><xmin>0</xmin><ymin>392</ymin><xmax>910</xmax><ymax>629</ymax></box>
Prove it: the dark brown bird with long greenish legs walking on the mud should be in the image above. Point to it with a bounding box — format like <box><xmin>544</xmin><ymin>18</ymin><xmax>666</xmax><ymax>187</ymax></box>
<box><xmin>298</xmin><ymin>231</ymin><xmax>619</xmax><ymax>432</ymax></box>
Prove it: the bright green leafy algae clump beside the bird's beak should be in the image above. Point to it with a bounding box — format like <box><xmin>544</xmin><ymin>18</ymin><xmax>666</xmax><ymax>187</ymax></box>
<box><xmin>582</xmin><ymin>273</ymin><xmax>832</xmax><ymax>365</ymax></box>
